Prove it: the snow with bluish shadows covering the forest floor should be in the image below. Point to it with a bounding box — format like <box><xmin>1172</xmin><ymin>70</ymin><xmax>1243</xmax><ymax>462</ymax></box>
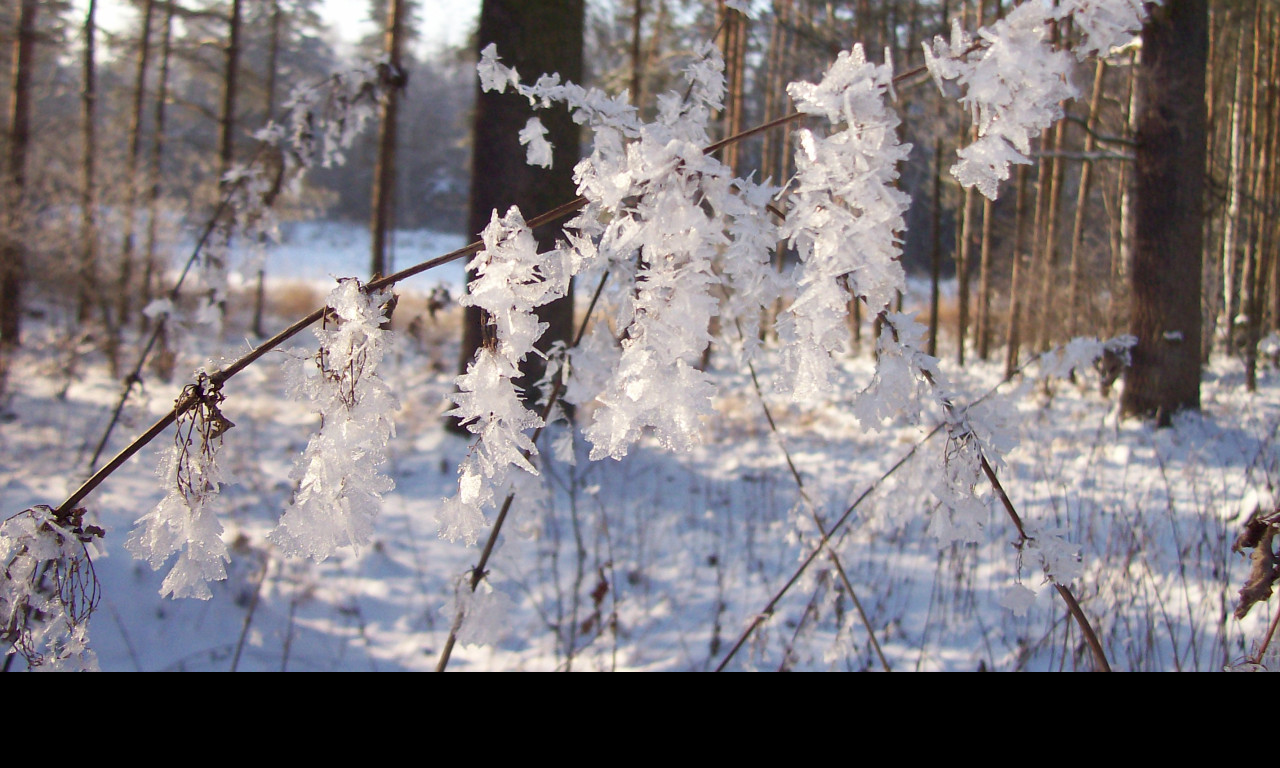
<box><xmin>0</xmin><ymin>229</ymin><xmax>1280</xmax><ymax>671</ymax></box>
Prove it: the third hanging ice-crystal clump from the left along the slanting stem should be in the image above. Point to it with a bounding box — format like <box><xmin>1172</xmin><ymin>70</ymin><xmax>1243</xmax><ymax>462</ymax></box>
<box><xmin>270</xmin><ymin>279</ymin><xmax>399</xmax><ymax>561</ymax></box>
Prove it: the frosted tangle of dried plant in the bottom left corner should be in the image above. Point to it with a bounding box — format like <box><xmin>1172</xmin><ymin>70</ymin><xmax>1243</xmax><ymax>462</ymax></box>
<box><xmin>0</xmin><ymin>507</ymin><xmax>97</xmax><ymax>672</ymax></box>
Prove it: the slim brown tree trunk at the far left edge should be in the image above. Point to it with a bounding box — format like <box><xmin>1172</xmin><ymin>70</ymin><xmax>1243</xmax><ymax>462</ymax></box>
<box><xmin>0</xmin><ymin>0</ymin><xmax>40</xmax><ymax>349</ymax></box>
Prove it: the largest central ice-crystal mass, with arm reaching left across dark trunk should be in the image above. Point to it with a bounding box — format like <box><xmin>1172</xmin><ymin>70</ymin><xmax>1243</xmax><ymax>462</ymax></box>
<box><xmin>480</xmin><ymin>45</ymin><xmax>781</xmax><ymax>460</ymax></box>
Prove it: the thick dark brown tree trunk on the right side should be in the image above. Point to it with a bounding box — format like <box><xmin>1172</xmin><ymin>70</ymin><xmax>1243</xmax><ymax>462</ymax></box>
<box><xmin>1121</xmin><ymin>0</ymin><xmax>1208</xmax><ymax>425</ymax></box>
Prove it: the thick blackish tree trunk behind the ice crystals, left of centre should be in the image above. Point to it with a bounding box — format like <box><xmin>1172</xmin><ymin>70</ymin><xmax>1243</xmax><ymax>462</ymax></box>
<box><xmin>451</xmin><ymin>0</ymin><xmax>585</xmax><ymax>428</ymax></box>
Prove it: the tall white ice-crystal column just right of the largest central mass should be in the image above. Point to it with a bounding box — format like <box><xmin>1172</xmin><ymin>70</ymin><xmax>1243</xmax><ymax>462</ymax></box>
<box><xmin>778</xmin><ymin>46</ymin><xmax>911</xmax><ymax>399</ymax></box>
